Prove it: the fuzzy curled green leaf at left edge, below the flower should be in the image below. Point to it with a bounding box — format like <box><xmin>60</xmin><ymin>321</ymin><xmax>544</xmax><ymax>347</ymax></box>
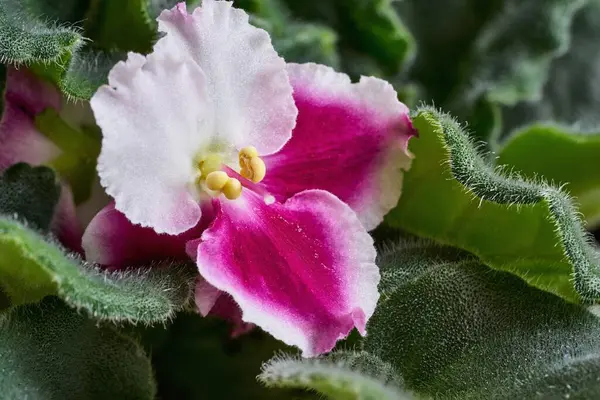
<box><xmin>0</xmin><ymin>218</ymin><xmax>195</xmax><ymax>318</ymax></box>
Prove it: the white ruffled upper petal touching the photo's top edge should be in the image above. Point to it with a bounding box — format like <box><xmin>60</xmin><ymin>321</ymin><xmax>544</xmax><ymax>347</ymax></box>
<box><xmin>155</xmin><ymin>0</ymin><xmax>297</xmax><ymax>154</ymax></box>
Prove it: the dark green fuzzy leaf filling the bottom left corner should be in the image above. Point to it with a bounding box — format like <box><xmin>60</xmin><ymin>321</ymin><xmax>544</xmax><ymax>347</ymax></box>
<box><xmin>0</xmin><ymin>298</ymin><xmax>156</xmax><ymax>400</ymax></box>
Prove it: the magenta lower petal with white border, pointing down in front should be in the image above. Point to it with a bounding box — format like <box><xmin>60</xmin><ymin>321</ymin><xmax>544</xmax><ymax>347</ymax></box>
<box><xmin>191</xmin><ymin>190</ymin><xmax>379</xmax><ymax>356</ymax></box>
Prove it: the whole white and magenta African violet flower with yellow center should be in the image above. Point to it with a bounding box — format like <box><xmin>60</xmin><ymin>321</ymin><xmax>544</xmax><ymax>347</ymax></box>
<box><xmin>84</xmin><ymin>0</ymin><xmax>413</xmax><ymax>356</ymax></box>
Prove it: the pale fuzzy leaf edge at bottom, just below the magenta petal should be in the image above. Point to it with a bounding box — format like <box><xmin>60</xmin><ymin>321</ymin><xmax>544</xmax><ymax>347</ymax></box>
<box><xmin>258</xmin><ymin>352</ymin><xmax>412</xmax><ymax>400</ymax></box>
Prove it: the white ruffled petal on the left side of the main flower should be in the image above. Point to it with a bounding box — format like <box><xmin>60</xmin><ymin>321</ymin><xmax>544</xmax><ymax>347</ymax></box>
<box><xmin>91</xmin><ymin>53</ymin><xmax>210</xmax><ymax>235</ymax></box>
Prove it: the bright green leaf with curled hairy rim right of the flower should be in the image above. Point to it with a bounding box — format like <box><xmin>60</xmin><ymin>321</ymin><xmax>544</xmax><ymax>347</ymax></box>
<box><xmin>386</xmin><ymin>108</ymin><xmax>600</xmax><ymax>301</ymax></box>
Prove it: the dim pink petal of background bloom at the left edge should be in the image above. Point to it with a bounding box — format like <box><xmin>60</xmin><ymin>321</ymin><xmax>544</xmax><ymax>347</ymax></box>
<box><xmin>0</xmin><ymin>67</ymin><xmax>61</xmax><ymax>170</ymax></box>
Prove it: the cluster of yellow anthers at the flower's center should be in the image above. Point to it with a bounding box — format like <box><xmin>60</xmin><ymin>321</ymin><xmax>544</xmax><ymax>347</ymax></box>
<box><xmin>196</xmin><ymin>146</ymin><xmax>267</xmax><ymax>200</ymax></box>
